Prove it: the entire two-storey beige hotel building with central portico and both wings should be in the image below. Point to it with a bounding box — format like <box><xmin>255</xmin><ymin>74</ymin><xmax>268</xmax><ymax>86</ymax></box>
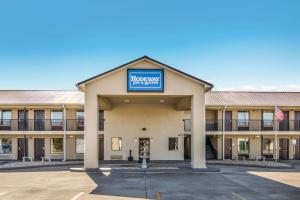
<box><xmin>0</xmin><ymin>56</ymin><xmax>300</xmax><ymax>169</ymax></box>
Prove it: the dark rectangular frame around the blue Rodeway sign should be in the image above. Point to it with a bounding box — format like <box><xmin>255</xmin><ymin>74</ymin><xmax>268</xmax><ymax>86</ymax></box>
<box><xmin>127</xmin><ymin>68</ymin><xmax>165</xmax><ymax>93</ymax></box>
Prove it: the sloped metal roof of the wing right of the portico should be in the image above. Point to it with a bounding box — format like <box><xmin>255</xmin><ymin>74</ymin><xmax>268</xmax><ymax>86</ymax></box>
<box><xmin>205</xmin><ymin>91</ymin><xmax>300</xmax><ymax>106</ymax></box>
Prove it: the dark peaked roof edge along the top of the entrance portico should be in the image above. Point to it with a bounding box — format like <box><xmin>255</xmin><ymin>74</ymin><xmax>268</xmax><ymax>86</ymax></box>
<box><xmin>76</xmin><ymin>55</ymin><xmax>214</xmax><ymax>91</ymax></box>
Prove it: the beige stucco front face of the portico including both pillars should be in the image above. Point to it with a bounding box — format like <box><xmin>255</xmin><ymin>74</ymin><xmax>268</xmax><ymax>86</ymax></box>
<box><xmin>84</xmin><ymin>60</ymin><xmax>205</xmax><ymax>168</ymax></box>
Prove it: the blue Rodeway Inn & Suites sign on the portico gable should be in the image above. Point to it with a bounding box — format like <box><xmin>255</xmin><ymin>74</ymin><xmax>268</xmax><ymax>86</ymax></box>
<box><xmin>127</xmin><ymin>69</ymin><xmax>164</xmax><ymax>92</ymax></box>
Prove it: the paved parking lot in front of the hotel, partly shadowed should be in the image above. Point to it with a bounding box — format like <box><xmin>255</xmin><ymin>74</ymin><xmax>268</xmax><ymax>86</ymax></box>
<box><xmin>0</xmin><ymin>163</ymin><xmax>300</xmax><ymax>200</ymax></box>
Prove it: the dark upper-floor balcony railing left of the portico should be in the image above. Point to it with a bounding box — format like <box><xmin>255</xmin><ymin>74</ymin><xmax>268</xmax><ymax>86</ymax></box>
<box><xmin>0</xmin><ymin>119</ymin><xmax>84</xmax><ymax>131</ymax></box>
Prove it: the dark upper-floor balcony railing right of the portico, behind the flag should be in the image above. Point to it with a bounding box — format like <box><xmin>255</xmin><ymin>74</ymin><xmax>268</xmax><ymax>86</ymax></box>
<box><xmin>206</xmin><ymin>119</ymin><xmax>300</xmax><ymax>131</ymax></box>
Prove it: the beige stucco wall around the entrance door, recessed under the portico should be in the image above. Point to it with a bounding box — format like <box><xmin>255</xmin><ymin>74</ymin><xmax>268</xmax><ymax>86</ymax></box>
<box><xmin>103</xmin><ymin>104</ymin><xmax>184</xmax><ymax>160</ymax></box>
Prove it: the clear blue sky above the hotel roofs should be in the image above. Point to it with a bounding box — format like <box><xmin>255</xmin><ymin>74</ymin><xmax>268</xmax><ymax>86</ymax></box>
<box><xmin>0</xmin><ymin>0</ymin><xmax>300</xmax><ymax>91</ymax></box>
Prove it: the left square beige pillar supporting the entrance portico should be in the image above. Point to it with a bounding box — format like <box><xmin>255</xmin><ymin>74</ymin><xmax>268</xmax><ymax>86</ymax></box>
<box><xmin>84</xmin><ymin>91</ymin><xmax>99</xmax><ymax>170</ymax></box>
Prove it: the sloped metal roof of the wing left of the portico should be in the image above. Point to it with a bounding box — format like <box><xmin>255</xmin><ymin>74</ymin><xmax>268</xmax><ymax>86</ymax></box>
<box><xmin>0</xmin><ymin>90</ymin><xmax>84</xmax><ymax>105</ymax></box>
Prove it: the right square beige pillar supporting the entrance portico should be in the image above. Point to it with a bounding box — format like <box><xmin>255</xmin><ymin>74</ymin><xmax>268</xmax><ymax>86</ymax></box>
<box><xmin>191</xmin><ymin>93</ymin><xmax>206</xmax><ymax>169</ymax></box>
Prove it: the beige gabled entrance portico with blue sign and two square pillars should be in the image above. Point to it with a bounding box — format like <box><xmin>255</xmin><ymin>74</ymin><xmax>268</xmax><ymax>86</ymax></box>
<box><xmin>78</xmin><ymin>56</ymin><xmax>212</xmax><ymax>169</ymax></box>
